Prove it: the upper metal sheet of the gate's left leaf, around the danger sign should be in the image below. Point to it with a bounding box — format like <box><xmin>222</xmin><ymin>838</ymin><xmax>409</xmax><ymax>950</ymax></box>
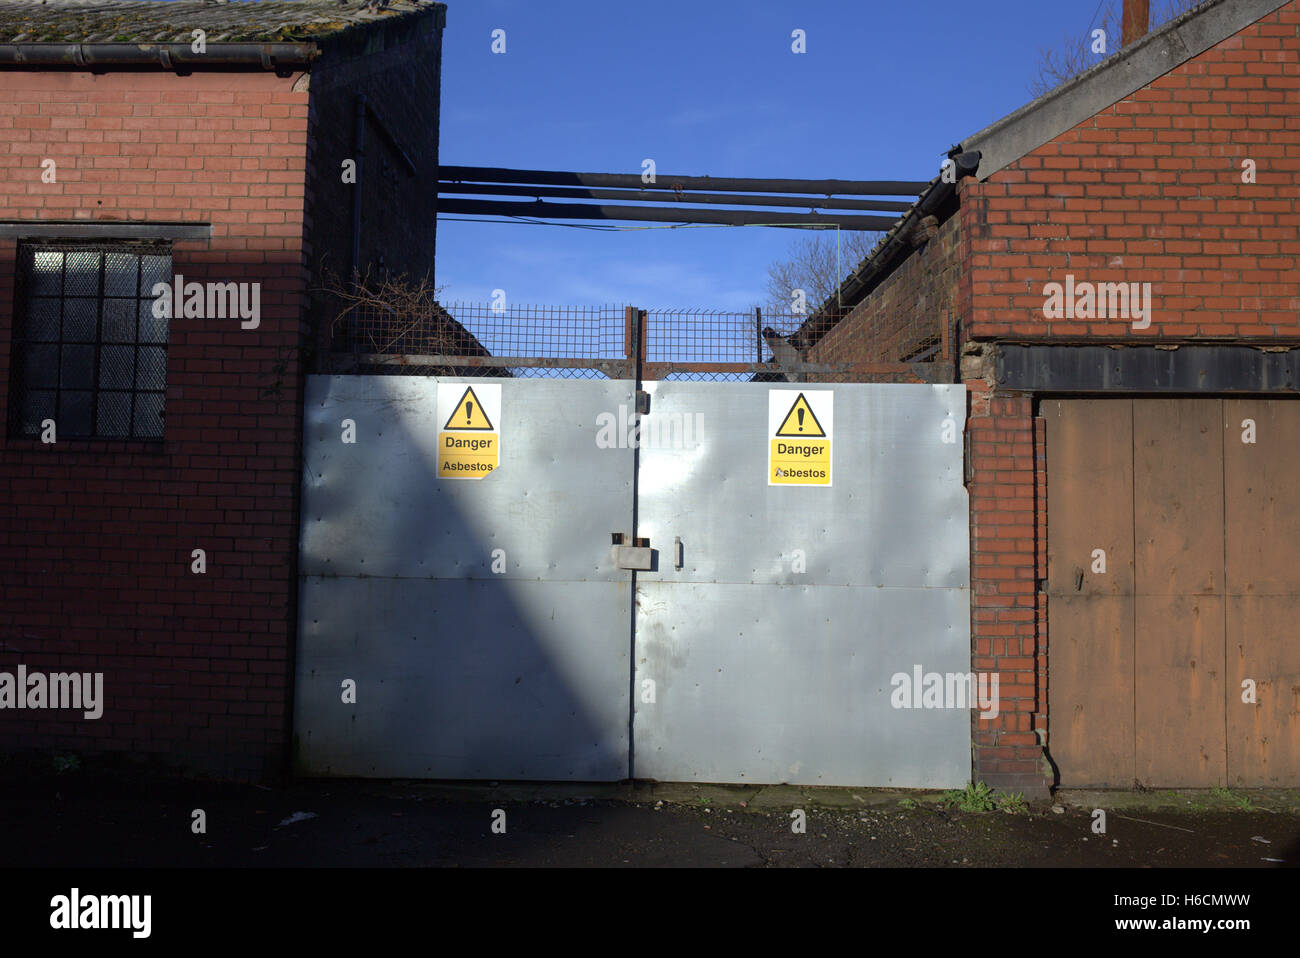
<box><xmin>300</xmin><ymin>376</ymin><xmax>633</xmax><ymax>582</ymax></box>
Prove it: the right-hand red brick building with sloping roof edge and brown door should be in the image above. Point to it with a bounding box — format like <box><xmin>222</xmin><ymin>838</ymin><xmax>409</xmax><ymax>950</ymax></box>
<box><xmin>803</xmin><ymin>0</ymin><xmax>1300</xmax><ymax>794</ymax></box>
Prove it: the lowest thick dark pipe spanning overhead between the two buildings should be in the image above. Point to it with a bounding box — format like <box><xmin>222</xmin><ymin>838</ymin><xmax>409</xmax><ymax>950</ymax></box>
<box><xmin>438</xmin><ymin>196</ymin><xmax>896</xmax><ymax>230</ymax></box>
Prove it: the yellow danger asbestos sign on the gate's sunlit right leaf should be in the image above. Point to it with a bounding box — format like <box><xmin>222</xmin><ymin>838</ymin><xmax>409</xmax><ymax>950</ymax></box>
<box><xmin>767</xmin><ymin>389</ymin><xmax>835</xmax><ymax>486</ymax></box>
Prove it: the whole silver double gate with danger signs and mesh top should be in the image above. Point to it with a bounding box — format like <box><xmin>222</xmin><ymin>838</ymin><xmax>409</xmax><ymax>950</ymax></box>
<box><xmin>295</xmin><ymin>304</ymin><xmax>972</xmax><ymax>788</ymax></box>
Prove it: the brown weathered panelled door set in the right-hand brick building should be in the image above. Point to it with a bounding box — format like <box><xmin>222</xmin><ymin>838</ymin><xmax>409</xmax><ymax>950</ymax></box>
<box><xmin>1041</xmin><ymin>399</ymin><xmax>1300</xmax><ymax>786</ymax></box>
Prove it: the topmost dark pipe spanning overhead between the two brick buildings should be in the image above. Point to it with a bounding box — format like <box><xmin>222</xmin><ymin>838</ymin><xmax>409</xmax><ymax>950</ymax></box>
<box><xmin>438</xmin><ymin>166</ymin><xmax>930</xmax><ymax>196</ymax></box>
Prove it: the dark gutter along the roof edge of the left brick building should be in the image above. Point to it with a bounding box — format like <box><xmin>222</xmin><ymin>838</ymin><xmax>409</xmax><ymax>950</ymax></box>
<box><xmin>0</xmin><ymin>43</ymin><xmax>320</xmax><ymax>75</ymax></box>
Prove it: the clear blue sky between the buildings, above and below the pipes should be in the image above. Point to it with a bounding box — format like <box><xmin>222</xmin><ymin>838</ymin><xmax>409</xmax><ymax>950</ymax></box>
<box><xmin>437</xmin><ymin>0</ymin><xmax>1097</xmax><ymax>309</ymax></box>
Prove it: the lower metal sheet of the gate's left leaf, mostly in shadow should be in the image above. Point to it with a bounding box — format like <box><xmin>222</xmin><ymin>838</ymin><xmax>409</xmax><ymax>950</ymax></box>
<box><xmin>295</xmin><ymin>576</ymin><xmax>632</xmax><ymax>781</ymax></box>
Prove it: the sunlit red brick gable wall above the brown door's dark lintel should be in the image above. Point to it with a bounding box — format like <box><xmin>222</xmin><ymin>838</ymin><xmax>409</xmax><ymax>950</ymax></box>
<box><xmin>962</xmin><ymin>3</ymin><xmax>1300</xmax><ymax>341</ymax></box>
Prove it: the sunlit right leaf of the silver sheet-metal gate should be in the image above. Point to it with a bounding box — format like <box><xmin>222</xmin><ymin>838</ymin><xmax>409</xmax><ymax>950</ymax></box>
<box><xmin>633</xmin><ymin>381</ymin><xmax>971</xmax><ymax>788</ymax></box>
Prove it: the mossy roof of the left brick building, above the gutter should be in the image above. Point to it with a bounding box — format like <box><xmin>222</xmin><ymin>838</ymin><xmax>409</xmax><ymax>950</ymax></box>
<box><xmin>0</xmin><ymin>0</ymin><xmax>441</xmax><ymax>43</ymax></box>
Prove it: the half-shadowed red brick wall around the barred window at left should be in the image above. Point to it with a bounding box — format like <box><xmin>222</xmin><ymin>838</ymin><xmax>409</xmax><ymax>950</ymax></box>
<box><xmin>0</xmin><ymin>71</ymin><xmax>308</xmax><ymax>777</ymax></box>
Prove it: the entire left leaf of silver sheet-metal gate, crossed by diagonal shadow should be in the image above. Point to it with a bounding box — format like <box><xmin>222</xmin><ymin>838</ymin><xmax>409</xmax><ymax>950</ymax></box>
<box><xmin>295</xmin><ymin>376</ymin><xmax>633</xmax><ymax>780</ymax></box>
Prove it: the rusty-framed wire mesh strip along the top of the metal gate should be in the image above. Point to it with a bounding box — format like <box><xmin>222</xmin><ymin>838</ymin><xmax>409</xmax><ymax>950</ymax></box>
<box><xmin>327</xmin><ymin>302</ymin><xmax>952</xmax><ymax>382</ymax></box>
